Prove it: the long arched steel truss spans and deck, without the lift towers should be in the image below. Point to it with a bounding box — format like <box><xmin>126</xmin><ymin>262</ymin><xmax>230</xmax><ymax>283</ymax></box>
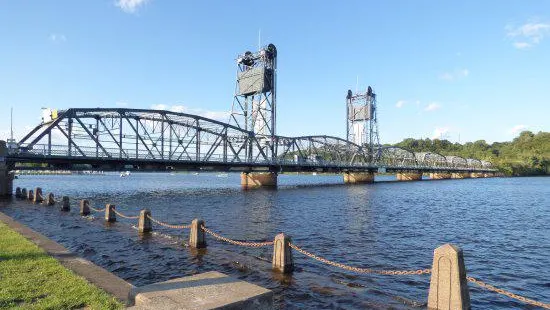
<box><xmin>6</xmin><ymin>108</ymin><xmax>496</xmax><ymax>173</ymax></box>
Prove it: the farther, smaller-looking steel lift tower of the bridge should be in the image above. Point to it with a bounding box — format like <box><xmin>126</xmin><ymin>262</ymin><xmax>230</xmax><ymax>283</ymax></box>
<box><xmin>346</xmin><ymin>86</ymin><xmax>380</xmax><ymax>160</ymax></box>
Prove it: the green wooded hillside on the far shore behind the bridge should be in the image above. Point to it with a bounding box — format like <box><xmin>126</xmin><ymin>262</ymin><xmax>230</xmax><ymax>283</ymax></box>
<box><xmin>395</xmin><ymin>131</ymin><xmax>550</xmax><ymax>176</ymax></box>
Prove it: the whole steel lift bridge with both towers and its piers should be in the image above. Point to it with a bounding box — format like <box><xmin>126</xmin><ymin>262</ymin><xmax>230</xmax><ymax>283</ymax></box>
<box><xmin>4</xmin><ymin>44</ymin><xmax>496</xmax><ymax>187</ymax></box>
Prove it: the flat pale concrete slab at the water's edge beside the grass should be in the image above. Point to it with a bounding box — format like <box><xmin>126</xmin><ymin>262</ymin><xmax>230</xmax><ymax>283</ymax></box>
<box><xmin>129</xmin><ymin>271</ymin><xmax>273</xmax><ymax>310</ymax></box>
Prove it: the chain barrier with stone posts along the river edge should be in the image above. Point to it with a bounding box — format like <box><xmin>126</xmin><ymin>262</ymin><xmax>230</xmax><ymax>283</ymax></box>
<box><xmin>15</xmin><ymin>187</ymin><xmax>550</xmax><ymax>309</ymax></box>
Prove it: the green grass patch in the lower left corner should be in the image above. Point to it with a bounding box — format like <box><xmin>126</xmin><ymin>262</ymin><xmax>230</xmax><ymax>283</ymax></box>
<box><xmin>0</xmin><ymin>222</ymin><xmax>123</xmax><ymax>309</ymax></box>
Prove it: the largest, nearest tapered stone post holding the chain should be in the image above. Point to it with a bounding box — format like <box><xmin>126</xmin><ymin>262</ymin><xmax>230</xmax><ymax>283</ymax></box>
<box><xmin>428</xmin><ymin>243</ymin><xmax>470</xmax><ymax>310</ymax></box>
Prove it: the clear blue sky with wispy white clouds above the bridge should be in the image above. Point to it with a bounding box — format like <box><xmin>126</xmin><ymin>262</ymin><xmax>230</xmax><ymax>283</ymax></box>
<box><xmin>0</xmin><ymin>0</ymin><xmax>550</xmax><ymax>143</ymax></box>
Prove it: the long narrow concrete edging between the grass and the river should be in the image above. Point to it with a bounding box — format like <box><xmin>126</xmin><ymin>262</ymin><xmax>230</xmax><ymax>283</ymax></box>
<box><xmin>0</xmin><ymin>212</ymin><xmax>135</xmax><ymax>305</ymax></box>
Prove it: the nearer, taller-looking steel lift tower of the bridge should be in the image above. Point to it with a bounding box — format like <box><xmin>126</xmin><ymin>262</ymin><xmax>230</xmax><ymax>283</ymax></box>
<box><xmin>229</xmin><ymin>44</ymin><xmax>277</xmax><ymax>159</ymax></box>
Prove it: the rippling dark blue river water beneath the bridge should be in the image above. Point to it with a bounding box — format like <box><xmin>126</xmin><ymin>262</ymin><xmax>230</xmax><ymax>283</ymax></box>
<box><xmin>0</xmin><ymin>173</ymin><xmax>550</xmax><ymax>309</ymax></box>
